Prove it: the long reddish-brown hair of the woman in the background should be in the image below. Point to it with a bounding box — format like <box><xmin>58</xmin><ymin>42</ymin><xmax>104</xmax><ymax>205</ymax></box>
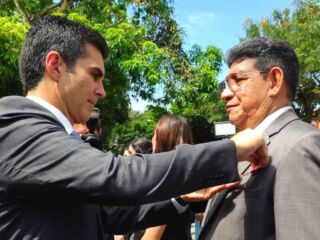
<box><xmin>154</xmin><ymin>115</ymin><xmax>193</xmax><ymax>153</ymax></box>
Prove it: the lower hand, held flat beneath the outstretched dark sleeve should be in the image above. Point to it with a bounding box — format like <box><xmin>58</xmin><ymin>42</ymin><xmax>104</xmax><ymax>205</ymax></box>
<box><xmin>180</xmin><ymin>181</ymin><xmax>241</xmax><ymax>202</ymax></box>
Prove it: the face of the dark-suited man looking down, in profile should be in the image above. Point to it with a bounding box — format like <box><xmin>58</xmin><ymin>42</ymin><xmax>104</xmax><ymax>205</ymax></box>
<box><xmin>58</xmin><ymin>44</ymin><xmax>106</xmax><ymax>123</ymax></box>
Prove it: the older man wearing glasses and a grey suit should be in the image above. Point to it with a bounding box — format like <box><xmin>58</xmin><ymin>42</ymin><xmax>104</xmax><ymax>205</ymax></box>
<box><xmin>200</xmin><ymin>37</ymin><xmax>320</xmax><ymax>240</ymax></box>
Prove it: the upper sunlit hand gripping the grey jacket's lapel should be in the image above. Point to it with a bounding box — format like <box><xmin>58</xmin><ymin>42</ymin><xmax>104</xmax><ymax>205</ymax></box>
<box><xmin>231</xmin><ymin>129</ymin><xmax>269</xmax><ymax>171</ymax></box>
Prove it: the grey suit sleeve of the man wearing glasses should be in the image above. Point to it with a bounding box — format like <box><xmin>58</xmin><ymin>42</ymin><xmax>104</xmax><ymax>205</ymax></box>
<box><xmin>274</xmin><ymin>132</ymin><xmax>320</xmax><ymax>240</ymax></box>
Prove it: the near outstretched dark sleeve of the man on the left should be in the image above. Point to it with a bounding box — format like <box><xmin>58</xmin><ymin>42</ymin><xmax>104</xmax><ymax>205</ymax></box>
<box><xmin>0</xmin><ymin>112</ymin><xmax>239</xmax><ymax>205</ymax></box>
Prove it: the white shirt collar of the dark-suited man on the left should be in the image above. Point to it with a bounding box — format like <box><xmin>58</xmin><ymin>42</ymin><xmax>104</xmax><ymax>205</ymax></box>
<box><xmin>27</xmin><ymin>96</ymin><xmax>73</xmax><ymax>134</ymax></box>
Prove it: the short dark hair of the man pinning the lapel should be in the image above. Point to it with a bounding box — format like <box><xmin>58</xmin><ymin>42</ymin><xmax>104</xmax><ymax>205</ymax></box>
<box><xmin>19</xmin><ymin>15</ymin><xmax>108</xmax><ymax>91</ymax></box>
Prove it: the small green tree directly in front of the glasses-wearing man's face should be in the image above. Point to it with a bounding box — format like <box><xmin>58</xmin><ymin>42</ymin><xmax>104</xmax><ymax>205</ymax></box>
<box><xmin>171</xmin><ymin>45</ymin><xmax>226</xmax><ymax>143</ymax></box>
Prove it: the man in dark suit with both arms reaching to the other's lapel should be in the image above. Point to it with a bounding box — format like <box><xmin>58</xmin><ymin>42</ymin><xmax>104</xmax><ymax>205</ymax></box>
<box><xmin>0</xmin><ymin>16</ymin><xmax>268</xmax><ymax>240</ymax></box>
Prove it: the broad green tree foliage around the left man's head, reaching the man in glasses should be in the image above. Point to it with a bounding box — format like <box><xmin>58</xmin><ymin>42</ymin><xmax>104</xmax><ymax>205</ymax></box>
<box><xmin>0</xmin><ymin>0</ymin><xmax>222</xmax><ymax>148</ymax></box>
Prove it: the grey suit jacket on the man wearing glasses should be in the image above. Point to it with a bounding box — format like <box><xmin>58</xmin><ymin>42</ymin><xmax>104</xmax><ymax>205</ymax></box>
<box><xmin>200</xmin><ymin>111</ymin><xmax>320</xmax><ymax>240</ymax></box>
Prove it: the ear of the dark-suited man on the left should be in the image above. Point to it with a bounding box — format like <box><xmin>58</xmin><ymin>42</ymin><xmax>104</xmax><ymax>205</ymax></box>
<box><xmin>45</xmin><ymin>51</ymin><xmax>64</xmax><ymax>81</ymax></box>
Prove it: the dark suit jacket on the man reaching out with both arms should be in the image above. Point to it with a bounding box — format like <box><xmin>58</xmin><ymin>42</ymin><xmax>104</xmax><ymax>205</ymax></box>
<box><xmin>0</xmin><ymin>97</ymin><xmax>238</xmax><ymax>240</ymax></box>
